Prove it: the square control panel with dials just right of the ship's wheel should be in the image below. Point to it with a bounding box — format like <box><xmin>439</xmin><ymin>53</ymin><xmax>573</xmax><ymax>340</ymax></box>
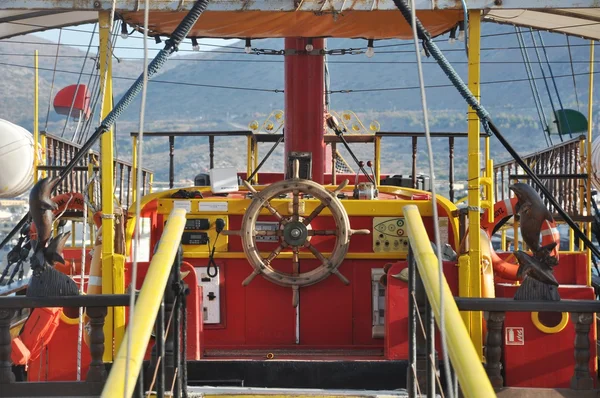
<box><xmin>373</xmin><ymin>217</ymin><xmax>408</xmax><ymax>254</ymax></box>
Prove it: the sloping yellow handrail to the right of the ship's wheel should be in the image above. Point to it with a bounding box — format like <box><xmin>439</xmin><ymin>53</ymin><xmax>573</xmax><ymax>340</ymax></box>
<box><xmin>403</xmin><ymin>205</ymin><xmax>496</xmax><ymax>398</ymax></box>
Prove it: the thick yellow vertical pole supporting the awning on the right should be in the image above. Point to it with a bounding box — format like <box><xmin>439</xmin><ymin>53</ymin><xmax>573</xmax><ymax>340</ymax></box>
<box><xmin>460</xmin><ymin>10</ymin><xmax>483</xmax><ymax>358</ymax></box>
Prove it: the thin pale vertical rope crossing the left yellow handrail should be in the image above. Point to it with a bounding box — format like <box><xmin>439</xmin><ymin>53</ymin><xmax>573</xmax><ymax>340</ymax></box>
<box><xmin>124</xmin><ymin>0</ymin><xmax>150</xmax><ymax>398</ymax></box>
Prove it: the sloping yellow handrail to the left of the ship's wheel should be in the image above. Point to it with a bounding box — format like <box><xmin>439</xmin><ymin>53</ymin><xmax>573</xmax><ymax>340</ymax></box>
<box><xmin>102</xmin><ymin>209</ymin><xmax>186</xmax><ymax>398</ymax></box>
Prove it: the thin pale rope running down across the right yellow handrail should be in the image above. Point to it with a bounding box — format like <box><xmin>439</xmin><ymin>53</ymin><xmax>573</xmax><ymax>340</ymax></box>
<box><xmin>406</xmin><ymin>0</ymin><xmax>452</xmax><ymax>398</ymax></box>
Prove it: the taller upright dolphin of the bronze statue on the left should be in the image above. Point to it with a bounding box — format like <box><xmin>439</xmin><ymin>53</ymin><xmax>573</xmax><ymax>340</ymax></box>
<box><xmin>29</xmin><ymin>177</ymin><xmax>58</xmax><ymax>265</ymax></box>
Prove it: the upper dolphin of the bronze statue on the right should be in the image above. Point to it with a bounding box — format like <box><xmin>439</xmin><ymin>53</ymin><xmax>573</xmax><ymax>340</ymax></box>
<box><xmin>508</xmin><ymin>183</ymin><xmax>554</xmax><ymax>253</ymax></box>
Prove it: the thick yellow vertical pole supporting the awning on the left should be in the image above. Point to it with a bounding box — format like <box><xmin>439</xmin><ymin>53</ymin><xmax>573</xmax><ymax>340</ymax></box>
<box><xmin>98</xmin><ymin>11</ymin><xmax>116</xmax><ymax>362</ymax></box>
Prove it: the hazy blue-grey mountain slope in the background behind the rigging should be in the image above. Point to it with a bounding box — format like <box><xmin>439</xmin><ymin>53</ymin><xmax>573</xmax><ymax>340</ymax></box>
<box><xmin>0</xmin><ymin>23</ymin><xmax>600</xmax><ymax>187</ymax></box>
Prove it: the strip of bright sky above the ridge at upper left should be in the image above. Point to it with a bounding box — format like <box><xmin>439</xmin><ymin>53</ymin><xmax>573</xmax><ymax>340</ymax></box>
<box><xmin>34</xmin><ymin>21</ymin><xmax>240</xmax><ymax>58</ymax></box>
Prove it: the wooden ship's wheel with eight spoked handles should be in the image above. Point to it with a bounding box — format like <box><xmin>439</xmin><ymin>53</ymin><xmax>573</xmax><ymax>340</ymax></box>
<box><xmin>223</xmin><ymin>161</ymin><xmax>370</xmax><ymax>307</ymax></box>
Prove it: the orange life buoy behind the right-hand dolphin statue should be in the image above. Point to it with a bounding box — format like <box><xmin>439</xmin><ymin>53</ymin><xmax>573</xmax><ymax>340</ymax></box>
<box><xmin>480</xmin><ymin>198</ymin><xmax>560</xmax><ymax>281</ymax></box>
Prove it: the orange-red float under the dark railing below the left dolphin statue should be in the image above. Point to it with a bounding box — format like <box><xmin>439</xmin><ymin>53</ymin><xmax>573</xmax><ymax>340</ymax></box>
<box><xmin>11</xmin><ymin>307</ymin><xmax>62</xmax><ymax>365</ymax></box>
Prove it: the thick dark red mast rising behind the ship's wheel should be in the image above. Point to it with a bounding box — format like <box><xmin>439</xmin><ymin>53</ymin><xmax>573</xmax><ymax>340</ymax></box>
<box><xmin>284</xmin><ymin>38</ymin><xmax>325</xmax><ymax>184</ymax></box>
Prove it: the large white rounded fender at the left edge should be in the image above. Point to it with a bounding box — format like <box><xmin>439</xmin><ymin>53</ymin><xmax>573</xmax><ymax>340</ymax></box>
<box><xmin>0</xmin><ymin>119</ymin><xmax>34</xmax><ymax>198</ymax></box>
